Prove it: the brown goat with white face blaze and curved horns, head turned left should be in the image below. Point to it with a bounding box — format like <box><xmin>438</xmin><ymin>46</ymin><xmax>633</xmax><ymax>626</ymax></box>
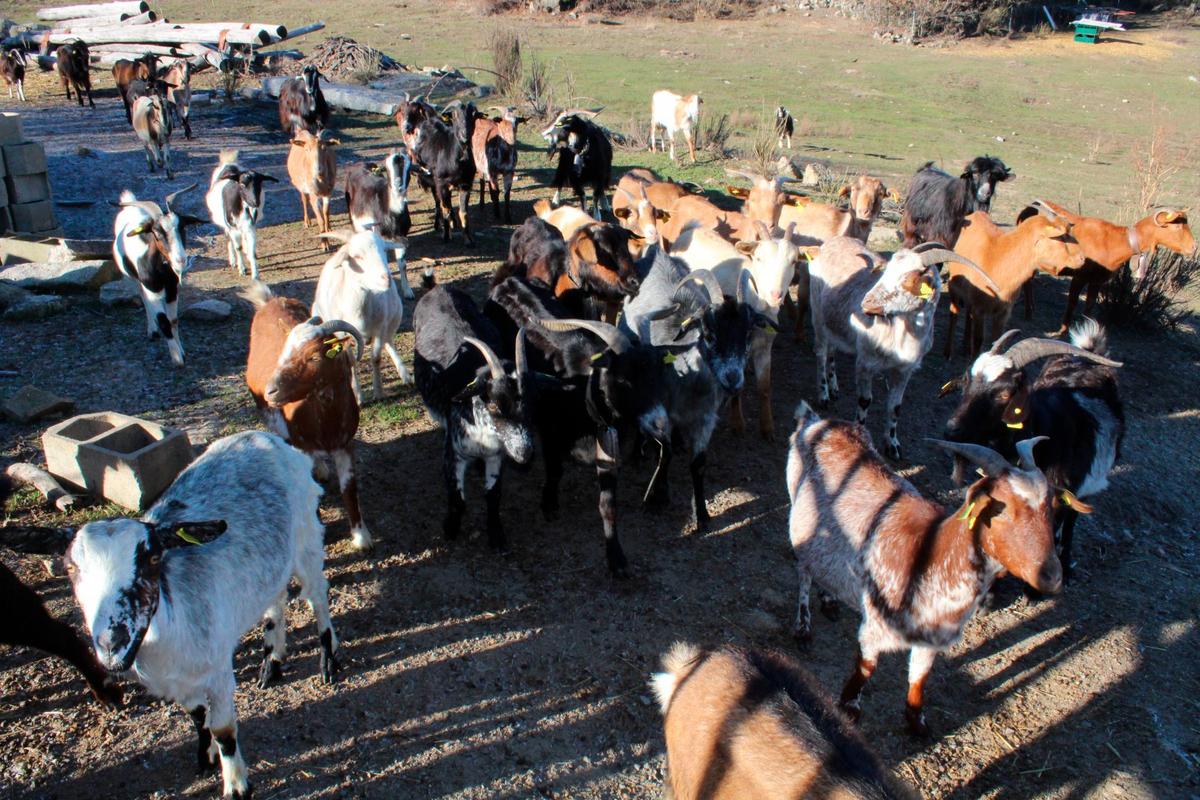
<box><xmin>244</xmin><ymin>282</ymin><xmax>372</xmax><ymax>551</ymax></box>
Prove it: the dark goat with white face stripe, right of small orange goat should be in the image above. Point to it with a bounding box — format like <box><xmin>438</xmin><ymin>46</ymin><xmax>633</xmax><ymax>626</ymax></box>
<box><xmin>346</xmin><ymin>150</ymin><xmax>417</xmax><ymax>300</ymax></box>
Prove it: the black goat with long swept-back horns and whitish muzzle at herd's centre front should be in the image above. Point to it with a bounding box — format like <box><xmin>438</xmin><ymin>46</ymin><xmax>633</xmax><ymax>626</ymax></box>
<box><xmin>484</xmin><ymin>277</ymin><xmax>668</xmax><ymax>577</ymax></box>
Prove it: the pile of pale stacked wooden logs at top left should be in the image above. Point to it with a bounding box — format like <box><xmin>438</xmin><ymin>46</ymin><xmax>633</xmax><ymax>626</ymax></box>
<box><xmin>4</xmin><ymin>0</ymin><xmax>325</xmax><ymax>70</ymax></box>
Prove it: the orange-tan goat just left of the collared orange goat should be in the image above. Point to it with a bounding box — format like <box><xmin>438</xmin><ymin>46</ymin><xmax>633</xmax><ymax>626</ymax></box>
<box><xmin>944</xmin><ymin>209</ymin><xmax>1085</xmax><ymax>359</ymax></box>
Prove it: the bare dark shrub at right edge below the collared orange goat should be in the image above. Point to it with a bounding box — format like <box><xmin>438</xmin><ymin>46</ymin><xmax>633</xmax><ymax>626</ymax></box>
<box><xmin>1100</xmin><ymin>247</ymin><xmax>1200</xmax><ymax>329</ymax></box>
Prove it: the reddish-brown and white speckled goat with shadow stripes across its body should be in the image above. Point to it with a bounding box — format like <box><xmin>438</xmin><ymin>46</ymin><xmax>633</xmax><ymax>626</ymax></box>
<box><xmin>787</xmin><ymin>402</ymin><xmax>1062</xmax><ymax>735</ymax></box>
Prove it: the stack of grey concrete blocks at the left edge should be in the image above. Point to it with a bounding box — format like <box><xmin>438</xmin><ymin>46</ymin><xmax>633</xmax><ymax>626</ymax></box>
<box><xmin>0</xmin><ymin>113</ymin><xmax>59</xmax><ymax>235</ymax></box>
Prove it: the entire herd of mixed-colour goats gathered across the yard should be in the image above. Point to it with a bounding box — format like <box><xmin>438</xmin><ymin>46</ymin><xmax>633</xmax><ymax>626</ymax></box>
<box><xmin>6</xmin><ymin>50</ymin><xmax>1195</xmax><ymax>799</ymax></box>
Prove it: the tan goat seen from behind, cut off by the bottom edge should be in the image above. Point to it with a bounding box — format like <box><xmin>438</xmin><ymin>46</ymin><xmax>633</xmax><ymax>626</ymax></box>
<box><xmin>650</xmin><ymin>642</ymin><xmax>914</xmax><ymax>800</ymax></box>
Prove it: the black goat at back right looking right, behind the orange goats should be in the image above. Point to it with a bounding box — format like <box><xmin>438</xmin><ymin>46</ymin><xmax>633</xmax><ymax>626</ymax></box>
<box><xmin>900</xmin><ymin>156</ymin><xmax>1016</xmax><ymax>249</ymax></box>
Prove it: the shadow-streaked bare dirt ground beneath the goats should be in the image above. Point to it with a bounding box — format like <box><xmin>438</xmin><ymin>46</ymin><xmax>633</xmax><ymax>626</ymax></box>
<box><xmin>0</xmin><ymin>61</ymin><xmax>1200</xmax><ymax>800</ymax></box>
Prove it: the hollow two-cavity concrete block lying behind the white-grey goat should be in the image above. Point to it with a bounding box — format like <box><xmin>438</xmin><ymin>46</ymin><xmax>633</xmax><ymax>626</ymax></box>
<box><xmin>42</xmin><ymin>411</ymin><xmax>192</xmax><ymax>511</ymax></box>
